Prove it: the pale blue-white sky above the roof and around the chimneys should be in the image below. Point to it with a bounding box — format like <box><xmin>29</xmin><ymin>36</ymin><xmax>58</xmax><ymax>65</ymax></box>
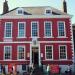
<box><xmin>0</xmin><ymin>0</ymin><xmax>75</xmax><ymax>23</ymax></box>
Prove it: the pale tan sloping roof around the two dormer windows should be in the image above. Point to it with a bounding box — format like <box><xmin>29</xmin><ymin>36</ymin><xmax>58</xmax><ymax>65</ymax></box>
<box><xmin>2</xmin><ymin>6</ymin><xmax>68</xmax><ymax>16</ymax></box>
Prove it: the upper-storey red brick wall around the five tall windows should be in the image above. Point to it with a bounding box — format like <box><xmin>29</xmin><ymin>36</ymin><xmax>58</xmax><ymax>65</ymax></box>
<box><xmin>0</xmin><ymin>19</ymin><xmax>71</xmax><ymax>41</ymax></box>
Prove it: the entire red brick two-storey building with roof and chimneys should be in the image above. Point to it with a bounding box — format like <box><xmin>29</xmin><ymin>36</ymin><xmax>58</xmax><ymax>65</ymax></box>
<box><xmin>0</xmin><ymin>0</ymin><xmax>73</xmax><ymax>72</ymax></box>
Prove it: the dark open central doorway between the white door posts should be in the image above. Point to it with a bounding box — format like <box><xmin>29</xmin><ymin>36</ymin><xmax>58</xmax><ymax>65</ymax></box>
<box><xmin>32</xmin><ymin>47</ymin><xmax>39</xmax><ymax>65</ymax></box>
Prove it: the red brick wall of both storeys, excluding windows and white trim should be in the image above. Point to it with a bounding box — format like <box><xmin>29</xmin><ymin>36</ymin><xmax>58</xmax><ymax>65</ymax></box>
<box><xmin>0</xmin><ymin>18</ymin><xmax>72</xmax><ymax>64</ymax></box>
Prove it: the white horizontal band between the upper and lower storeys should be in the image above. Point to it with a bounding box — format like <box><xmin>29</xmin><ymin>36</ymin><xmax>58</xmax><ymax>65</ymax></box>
<box><xmin>0</xmin><ymin>41</ymin><xmax>72</xmax><ymax>44</ymax></box>
